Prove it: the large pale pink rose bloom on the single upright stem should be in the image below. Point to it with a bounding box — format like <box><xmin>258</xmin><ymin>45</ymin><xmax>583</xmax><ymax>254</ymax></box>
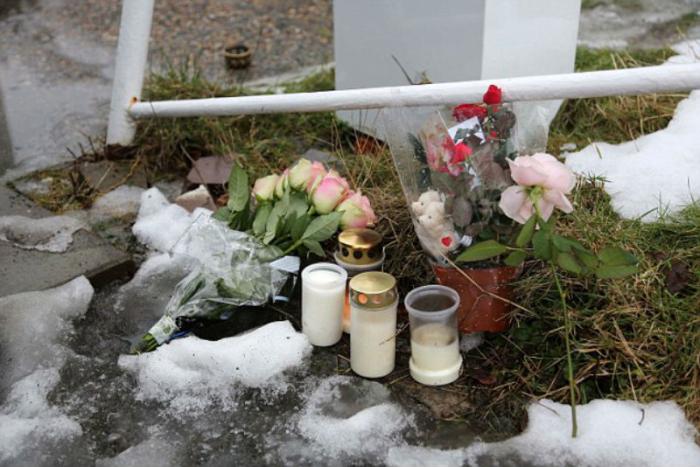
<box><xmin>498</xmin><ymin>153</ymin><xmax>576</xmax><ymax>224</ymax></box>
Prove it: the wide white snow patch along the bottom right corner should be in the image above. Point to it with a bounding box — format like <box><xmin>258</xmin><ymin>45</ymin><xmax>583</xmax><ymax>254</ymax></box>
<box><xmin>386</xmin><ymin>399</ymin><xmax>700</xmax><ymax>467</ymax></box>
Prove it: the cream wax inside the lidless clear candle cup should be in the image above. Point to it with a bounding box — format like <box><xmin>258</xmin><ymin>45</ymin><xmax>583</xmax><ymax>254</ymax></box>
<box><xmin>411</xmin><ymin>323</ymin><xmax>460</xmax><ymax>371</ymax></box>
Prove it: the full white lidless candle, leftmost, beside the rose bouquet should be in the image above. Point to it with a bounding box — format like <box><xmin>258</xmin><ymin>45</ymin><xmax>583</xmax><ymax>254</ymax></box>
<box><xmin>301</xmin><ymin>263</ymin><xmax>348</xmax><ymax>347</ymax></box>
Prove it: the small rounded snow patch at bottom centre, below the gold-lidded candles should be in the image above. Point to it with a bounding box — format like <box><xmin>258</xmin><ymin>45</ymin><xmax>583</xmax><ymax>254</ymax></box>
<box><xmin>298</xmin><ymin>376</ymin><xmax>413</xmax><ymax>457</ymax></box>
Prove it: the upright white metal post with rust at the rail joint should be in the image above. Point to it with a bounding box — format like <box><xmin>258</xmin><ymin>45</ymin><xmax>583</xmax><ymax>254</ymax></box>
<box><xmin>107</xmin><ymin>0</ymin><xmax>155</xmax><ymax>145</ymax></box>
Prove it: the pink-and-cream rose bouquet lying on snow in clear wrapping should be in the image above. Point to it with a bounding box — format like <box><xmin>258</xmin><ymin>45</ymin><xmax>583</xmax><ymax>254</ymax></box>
<box><xmin>133</xmin><ymin>159</ymin><xmax>376</xmax><ymax>352</ymax></box>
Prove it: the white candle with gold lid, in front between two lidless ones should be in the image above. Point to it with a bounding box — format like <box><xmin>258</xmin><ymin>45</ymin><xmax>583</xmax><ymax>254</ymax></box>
<box><xmin>350</xmin><ymin>271</ymin><xmax>399</xmax><ymax>378</ymax></box>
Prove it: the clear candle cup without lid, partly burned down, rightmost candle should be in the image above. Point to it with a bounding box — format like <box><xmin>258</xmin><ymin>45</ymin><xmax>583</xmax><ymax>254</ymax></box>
<box><xmin>404</xmin><ymin>285</ymin><xmax>462</xmax><ymax>386</ymax></box>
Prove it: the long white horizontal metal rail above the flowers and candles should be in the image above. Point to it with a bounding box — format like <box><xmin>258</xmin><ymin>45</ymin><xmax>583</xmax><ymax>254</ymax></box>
<box><xmin>129</xmin><ymin>64</ymin><xmax>700</xmax><ymax>118</ymax></box>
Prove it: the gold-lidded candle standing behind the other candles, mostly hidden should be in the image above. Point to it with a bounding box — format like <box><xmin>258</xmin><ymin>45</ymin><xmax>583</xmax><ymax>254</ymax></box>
<box><xmin>334</xmin><ymin>228</ymin><xmax>384</xmax><ymax>333</ymax></box>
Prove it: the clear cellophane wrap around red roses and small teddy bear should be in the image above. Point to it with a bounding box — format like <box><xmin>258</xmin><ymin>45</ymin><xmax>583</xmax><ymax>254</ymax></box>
<box><xmin>384</xmin><ymin>86</ymin><xmax>528</xmax><ymax>264</ymax></box>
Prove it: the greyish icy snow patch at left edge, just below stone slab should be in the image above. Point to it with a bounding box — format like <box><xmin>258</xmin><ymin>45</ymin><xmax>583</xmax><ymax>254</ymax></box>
<box><xmin>0</xmin><ymin>276</ymin><xmax>94</xmax><ymax>389</ymax></box>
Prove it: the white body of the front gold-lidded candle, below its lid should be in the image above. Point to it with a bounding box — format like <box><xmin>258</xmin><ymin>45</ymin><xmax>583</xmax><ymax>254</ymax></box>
<box><xmin>350</xmin><ymin>302</ymin><xmax>396</xmax><ymax>378</ymax></box>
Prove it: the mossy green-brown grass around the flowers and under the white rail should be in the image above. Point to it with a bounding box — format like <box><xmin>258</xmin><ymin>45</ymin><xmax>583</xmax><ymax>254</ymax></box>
<box><xmin>120</xmin><ymin>49</ymin><xmax>700</xmax><ymax>429</ymax></box>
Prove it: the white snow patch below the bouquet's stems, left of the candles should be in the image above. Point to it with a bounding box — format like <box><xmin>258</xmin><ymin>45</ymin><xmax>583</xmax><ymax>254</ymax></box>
<box><xmin>119</xmin><ymin>321</ymin><xmax>311</xmax><ymax>414</ymax></box>
